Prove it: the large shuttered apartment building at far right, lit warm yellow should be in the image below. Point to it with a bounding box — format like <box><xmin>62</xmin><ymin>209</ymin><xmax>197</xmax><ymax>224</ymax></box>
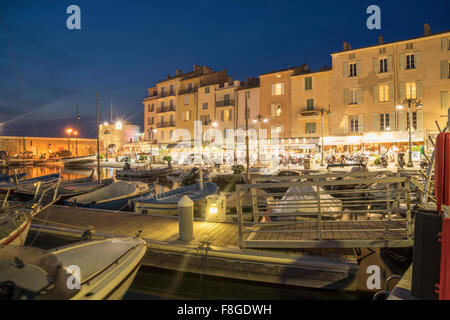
<box><xmin>327</xmin><ymin>25</ymin><xmax>450</xmax><ymax>148</ymax></box>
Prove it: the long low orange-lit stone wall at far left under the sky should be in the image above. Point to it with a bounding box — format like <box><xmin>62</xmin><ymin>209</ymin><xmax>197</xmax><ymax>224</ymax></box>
<box><xmin>0</xmin><ymin>136</ymin><xmax>97</xmax><ymax>156</ymax></box>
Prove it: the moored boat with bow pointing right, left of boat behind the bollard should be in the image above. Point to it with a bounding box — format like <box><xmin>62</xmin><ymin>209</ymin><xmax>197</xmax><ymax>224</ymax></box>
<box><xmin>64</xmin><ymin>181</ymin><xmax>154</xmax><ymax>210</ymax></box>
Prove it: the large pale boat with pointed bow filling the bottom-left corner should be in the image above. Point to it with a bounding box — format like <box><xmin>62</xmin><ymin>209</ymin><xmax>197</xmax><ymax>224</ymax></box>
<box><xmin>0</xmin><ymin>238</ymin><xmax>147</xmax><ymax>300</ymax></box>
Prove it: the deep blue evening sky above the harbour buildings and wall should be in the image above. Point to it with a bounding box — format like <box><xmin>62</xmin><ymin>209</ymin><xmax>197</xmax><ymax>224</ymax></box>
<box><xmin>0</xmin><ymin>0</ymin><xmax>450</xmax><ymax>137</ymax></box>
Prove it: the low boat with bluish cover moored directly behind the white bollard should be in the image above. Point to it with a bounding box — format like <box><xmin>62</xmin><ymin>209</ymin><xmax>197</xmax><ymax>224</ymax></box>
<box><xmin>133</xmin><ymin>182</ymin><xmax>218</xmax><ymax>215</ymax></box>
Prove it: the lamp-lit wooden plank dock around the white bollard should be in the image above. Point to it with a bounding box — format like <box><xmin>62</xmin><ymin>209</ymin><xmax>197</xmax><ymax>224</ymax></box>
<box><xmin>32</xmin><ymin>206</ymin><xmax>358</xmax><ymax>291</ymax></box>
